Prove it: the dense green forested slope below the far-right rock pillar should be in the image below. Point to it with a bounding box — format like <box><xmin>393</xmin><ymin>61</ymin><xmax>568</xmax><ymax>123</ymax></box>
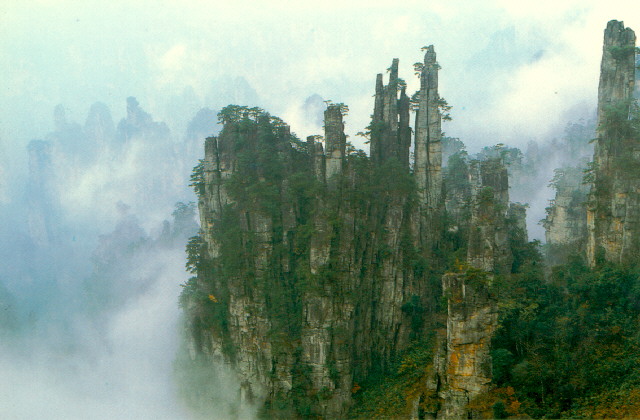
<box><xmin>492</xmin><ymin>260</ymin><xmax>640</xmax><ymax>418</ymax></box>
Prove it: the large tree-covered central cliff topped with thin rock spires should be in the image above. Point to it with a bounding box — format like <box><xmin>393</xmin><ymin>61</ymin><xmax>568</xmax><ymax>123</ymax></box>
<box><xmin>183</xmin><ymin>49</ymin><xmax>442</xmax><ymax>418</ymax></box>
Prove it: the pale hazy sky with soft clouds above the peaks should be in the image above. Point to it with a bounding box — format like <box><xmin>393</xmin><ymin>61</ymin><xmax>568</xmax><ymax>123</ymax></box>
<box><xmin>0</xmin><ymin>0</ymin><xmax>640</xmax><ymax>151</ymax></box>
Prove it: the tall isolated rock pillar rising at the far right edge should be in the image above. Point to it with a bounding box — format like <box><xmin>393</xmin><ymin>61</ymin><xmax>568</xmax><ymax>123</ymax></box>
<box><xmin>587</xmin><ymin>20</ymin><xmax>640</xmax><ymax>265</ymax></box>
